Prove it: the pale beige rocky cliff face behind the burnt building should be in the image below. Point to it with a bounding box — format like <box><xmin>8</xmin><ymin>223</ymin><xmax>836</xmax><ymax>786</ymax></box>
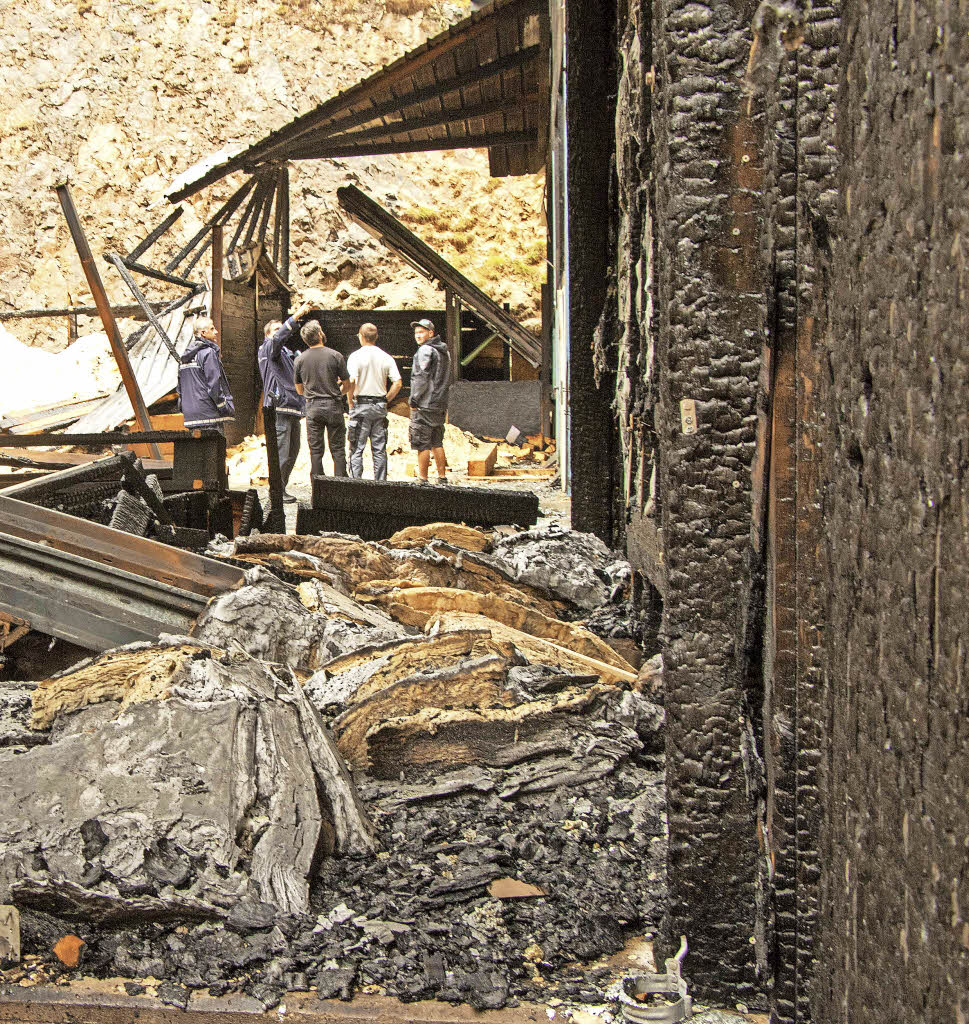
<box><xmin>0</xmin><ymin>0</ymin><xmax>544</xmax><ymax>348</ymax></box>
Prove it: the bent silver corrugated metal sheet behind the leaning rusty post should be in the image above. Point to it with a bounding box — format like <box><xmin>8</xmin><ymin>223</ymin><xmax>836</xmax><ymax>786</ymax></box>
<box><xmin>67</xmin><ymin>293</ymin><xmax>209</xmax><ymax>434</ymax></box>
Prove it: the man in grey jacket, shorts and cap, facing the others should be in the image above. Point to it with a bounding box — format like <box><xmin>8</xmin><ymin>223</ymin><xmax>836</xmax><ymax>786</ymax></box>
<box><xmin>410</xmin><ymin>319</ymin><xmax>451</xmax><ymax>483</ymax></box>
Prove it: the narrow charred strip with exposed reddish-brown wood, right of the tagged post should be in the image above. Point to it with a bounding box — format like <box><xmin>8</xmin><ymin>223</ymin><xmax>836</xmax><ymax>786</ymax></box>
<box><xmin>751</xmin><ymin>5</ymin><xmax>840</xmax><ymax>1024</ymax></box>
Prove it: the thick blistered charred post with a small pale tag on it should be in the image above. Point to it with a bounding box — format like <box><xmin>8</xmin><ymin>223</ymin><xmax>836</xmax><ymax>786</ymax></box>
<box><xmin>652</xmin><ymin>0</ymin><xmax>765</xmax><ymax>1002</ymax></box>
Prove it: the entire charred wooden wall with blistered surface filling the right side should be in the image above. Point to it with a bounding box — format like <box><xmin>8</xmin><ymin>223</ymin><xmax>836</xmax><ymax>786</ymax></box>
<box><xmin>572</xmin><ymin>0</ymin><xmax>969</xmax><ymax>1024</ymax></box>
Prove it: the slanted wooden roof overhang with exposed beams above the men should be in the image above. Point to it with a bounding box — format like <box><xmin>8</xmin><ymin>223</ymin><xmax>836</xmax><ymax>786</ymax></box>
<box><xmin>162</xmin><ymin>0</ymin><xmax>550</xmax><ymax>203</ymax></box>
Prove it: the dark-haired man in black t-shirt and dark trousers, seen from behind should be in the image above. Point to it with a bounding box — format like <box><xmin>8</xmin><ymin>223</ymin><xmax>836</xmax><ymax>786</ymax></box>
<box><xmin>293</xmin><ymin>321</ymin><xmax>349</xmax><ymax>476</ymax></box>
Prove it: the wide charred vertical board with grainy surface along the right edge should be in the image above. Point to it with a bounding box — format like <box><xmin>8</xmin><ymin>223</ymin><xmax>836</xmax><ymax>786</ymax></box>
<box><xmin>814</xmin><ymin>0</ymin><xmax>969</xmax><ymax>1024</ymax></box>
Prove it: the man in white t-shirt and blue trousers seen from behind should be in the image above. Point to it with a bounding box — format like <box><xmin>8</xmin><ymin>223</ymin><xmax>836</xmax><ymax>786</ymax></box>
<box><xmin>346</xmin><ymin>324</ymin><xmax>401</xmax><ymax>480</ymax></box>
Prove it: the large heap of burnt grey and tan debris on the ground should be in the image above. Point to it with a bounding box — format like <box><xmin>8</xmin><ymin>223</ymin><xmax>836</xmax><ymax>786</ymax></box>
<box><xmin>0</xmin><ymin>523</ymin><xmax>665</xmax><ymax>1008</ymax></box>
